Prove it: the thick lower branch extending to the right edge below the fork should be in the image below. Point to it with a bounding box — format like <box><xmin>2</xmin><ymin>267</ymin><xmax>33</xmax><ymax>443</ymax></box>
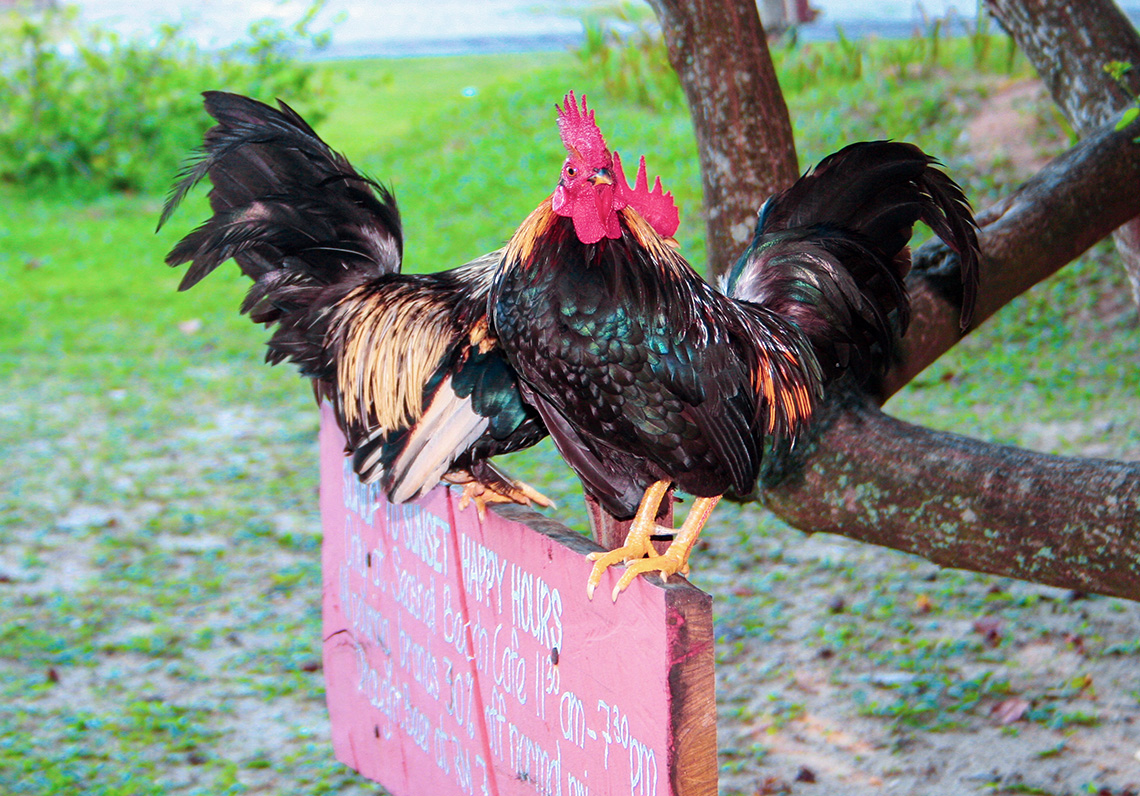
<box><xmin>763</xmin><ymin>397</ymin><xmax>1140</xmax><ymax>600</ymax></box>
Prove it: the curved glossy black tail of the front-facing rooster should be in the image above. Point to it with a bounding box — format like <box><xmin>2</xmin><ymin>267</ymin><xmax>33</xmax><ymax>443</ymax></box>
<box><xmin>725</xmin><ymin>141</ymin><xmax>978</xmax><ymax>376</ymax></box>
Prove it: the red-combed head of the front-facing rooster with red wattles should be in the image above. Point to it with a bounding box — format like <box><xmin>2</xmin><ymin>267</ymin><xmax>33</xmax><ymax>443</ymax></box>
<box><xmin>551</xmin><ymin>91</ymin><xmax>678</xmax><ymax>243</ymax></box>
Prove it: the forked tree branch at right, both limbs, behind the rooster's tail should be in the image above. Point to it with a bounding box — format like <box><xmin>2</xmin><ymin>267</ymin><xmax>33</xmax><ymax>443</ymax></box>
<box><xmin>762</xmin><ymin>116</ymin><xmax>1140</xmax><ymax>600</ymax></box>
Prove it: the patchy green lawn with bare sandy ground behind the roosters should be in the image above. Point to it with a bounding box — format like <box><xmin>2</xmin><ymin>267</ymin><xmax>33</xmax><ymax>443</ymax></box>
<box><xmin>0</xmin><ymin>27</ymin><xmax>1140</xmax><ymax>796</ymax></box>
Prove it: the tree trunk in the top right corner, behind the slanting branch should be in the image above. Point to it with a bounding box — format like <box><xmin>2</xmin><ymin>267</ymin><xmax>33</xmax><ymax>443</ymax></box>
<box><xmin>986</xmin><ymin>0</ymin><xmax>1140</xmax><ymax>306</ymax></box>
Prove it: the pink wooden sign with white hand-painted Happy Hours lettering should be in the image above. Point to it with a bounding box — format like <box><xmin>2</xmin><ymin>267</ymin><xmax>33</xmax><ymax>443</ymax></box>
<box><xmin>320</xmin><ymin>406</ymin><xmax>717</xmax><ymax>796</ymax></box>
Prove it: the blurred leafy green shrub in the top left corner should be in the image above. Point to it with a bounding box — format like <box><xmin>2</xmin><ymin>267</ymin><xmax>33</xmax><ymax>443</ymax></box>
<box><xmin>0</xmin><ymin>0</ymin><xmax>328</xmax><ymax>195</ymax></box>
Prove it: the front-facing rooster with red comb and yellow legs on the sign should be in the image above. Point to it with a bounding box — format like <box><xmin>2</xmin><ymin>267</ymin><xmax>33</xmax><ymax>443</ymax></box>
<box><xmin>488</xmin><ymin>91</ymin><xmax>977</xmax><ymax>600</ymax></box>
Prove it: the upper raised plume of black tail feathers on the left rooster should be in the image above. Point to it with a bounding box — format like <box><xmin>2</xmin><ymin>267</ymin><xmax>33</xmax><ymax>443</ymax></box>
<box><xmin>158</xmin><ymin>91</ymin><xmax>404</xmax><ymax>290</ymax></box>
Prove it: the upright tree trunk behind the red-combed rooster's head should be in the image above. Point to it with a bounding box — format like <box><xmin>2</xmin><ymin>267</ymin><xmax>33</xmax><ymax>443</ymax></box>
<box><xmin>650</xmin><ymin>0</ymin><xmax>798</xmax><ymax>274</ymax></box>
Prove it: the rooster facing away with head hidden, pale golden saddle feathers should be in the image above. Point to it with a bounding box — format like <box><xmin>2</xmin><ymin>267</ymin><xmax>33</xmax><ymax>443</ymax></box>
<box><xmin>158</xmin><ymin>91</ymin><xmax>549</xmax><ymax>514</ymax></box>
